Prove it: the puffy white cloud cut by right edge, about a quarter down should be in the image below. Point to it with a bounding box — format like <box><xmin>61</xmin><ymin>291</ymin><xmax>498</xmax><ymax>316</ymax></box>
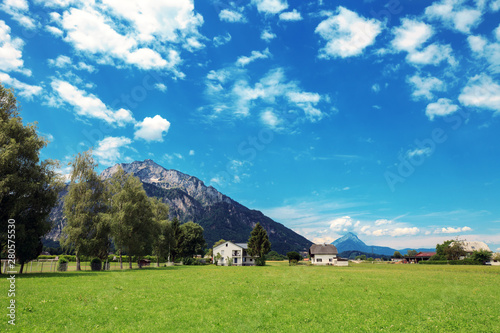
<box><xmin>458</xmin><ymin>74</ymin><xmax>500</xmax><ymax>114</ymax></box>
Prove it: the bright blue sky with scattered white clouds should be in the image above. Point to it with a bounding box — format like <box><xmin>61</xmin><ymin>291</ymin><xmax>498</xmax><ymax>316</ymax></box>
<box><xmin>0</xmin><ymin>0</ymin><xmax>500</xmax><ymax>251</ymax></box>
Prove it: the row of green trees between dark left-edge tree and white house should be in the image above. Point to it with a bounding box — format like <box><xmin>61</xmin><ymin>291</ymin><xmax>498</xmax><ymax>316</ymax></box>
<box><xmin>62</xmin><ymin>151</ymin><xmax>205</xmax><ymax>270</ymax></box>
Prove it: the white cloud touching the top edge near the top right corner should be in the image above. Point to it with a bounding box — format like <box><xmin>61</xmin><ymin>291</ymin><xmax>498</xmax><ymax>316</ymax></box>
<box><xmin>425</xmin><ymin>0</ymin><xmax>481</xmax><ymax>34</ymax></box>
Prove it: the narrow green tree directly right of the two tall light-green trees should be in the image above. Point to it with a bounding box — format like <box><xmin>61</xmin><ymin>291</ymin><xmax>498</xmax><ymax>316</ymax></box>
<box><xmin>150</xmin><ymin>198</ymin><xmax>175</xmax><ymax>267</ymax></box>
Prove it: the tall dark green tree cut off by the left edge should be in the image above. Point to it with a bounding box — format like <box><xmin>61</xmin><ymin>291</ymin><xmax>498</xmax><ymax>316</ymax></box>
<box><xmin>0</xmin><ymin>84</ymin><xmax>62</xmax><ymax>273</ymax></box>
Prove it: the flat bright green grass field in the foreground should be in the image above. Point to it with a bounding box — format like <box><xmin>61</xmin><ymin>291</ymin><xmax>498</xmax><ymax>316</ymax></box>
<box><xmin>0</xmin><ymin>263</ymin><xmax>500</xmax><ymax>332</ymax></box>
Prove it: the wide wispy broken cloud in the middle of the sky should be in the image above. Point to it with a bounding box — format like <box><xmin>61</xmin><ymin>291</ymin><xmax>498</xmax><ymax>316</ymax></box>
<box><xmin>205</xmin><ymin>67</ymin><xmax>328</xmax><ymax>121</ymax></box>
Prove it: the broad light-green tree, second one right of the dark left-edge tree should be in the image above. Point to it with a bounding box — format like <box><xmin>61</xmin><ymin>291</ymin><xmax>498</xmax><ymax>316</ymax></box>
<box><xmin>109</xmin><ymin>166</ymin><xmax>155</xmax><ymax>268</ymax></box>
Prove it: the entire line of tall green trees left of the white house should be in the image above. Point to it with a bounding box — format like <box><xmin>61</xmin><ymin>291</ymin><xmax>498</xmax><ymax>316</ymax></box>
<box><xmin>0</xmin><ymin>84</ymin><xmax>206</xmax><ymax>273</ymax></box>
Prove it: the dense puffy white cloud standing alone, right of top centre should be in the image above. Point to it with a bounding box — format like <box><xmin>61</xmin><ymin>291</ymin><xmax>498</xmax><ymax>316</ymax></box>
<box><xmin>315</xmin><ymin>6</ymin><xmax>383</xmax><ymax>59</ymax></box>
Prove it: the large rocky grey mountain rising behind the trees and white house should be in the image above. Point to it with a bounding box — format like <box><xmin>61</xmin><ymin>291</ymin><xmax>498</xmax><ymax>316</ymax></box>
<box><xmin>47</xmin><ymin>160</ymin><xmax>312</xmax><ymax>254</ymax></box>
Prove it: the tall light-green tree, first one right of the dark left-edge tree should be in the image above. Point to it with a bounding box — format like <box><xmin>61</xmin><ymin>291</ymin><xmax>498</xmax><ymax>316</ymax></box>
<box><xmin>62</xmin><ymin>150</ymin><xmax>111</xmax><ymax>271</ymax></box>
